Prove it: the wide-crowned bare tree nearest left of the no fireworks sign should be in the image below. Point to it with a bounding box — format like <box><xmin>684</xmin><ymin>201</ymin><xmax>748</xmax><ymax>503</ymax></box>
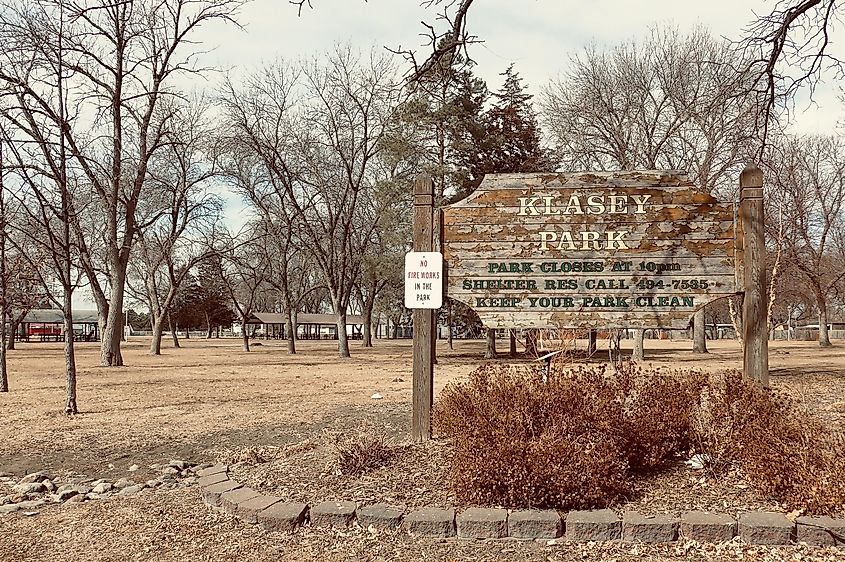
<box><xmin>222</xmin><ymin>47</ymin><xmax>403</xmax><ymax>357</ymax></box>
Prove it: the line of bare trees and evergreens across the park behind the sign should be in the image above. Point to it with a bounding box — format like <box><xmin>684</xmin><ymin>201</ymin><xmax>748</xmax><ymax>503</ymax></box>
<box><xmin>0</xmin><ymin>0</ymin><xmax>845</xmax><ymax>413</ymax></box>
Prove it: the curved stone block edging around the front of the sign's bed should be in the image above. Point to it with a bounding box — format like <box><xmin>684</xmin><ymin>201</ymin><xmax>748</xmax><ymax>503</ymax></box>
<box><xmin>198</xmin><ymin>464</ymin><xmax>845</xmax><ymax>546</ymax></box>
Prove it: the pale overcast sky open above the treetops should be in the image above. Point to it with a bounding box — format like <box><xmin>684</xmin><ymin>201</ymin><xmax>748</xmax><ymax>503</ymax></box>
<box><xmin>196</xmin><ymin>0</ymin><xmax>845</xmax><ymax>133</ymax></box>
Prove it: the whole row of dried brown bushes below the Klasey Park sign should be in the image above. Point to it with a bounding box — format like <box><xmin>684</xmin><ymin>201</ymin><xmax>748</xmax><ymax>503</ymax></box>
<box><xmin>434</xmin><ymin>364</ymin><xmax>845</xmax><ymax>513</ymax></box>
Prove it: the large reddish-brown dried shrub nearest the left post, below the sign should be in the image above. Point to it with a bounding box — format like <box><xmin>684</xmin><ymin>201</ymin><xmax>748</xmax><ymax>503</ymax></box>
<box><xmin>434</xmin><ymin>365</ymin><xmax>627</xmax><ymax>506</ymax></box>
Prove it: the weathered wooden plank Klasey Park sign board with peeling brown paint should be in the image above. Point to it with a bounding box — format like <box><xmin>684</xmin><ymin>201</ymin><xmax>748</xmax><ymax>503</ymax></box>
<box><xmin>442</xmin><ymin>171</ymin><xmax>737</xmax><ymax>328</ymax></box>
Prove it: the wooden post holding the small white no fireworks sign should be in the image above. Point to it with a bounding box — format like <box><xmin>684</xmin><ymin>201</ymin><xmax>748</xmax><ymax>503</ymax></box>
<box><xmin>411</xmin><ymin>174</ymin><xmax>437</xmax><ymax>443</ymax></box>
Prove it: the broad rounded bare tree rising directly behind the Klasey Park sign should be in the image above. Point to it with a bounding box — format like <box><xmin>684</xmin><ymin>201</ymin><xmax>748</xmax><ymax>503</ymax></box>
<box><xmin>541</xmin><ymin>28</ymin><xmax>756</xmax><ymax>359</ymax></box>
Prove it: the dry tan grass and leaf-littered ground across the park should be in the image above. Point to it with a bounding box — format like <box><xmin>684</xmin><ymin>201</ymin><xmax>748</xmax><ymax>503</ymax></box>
<box><xmin>0</xmin><ymin>339</ymin><xmax>845</xmax><ymax>562</ymax></box>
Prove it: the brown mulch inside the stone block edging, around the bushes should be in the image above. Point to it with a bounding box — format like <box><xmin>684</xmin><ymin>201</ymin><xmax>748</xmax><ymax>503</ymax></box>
<box><xmin>224</xmin><ymin>440</ymin><xmax>786</xmax><ymax>516</ymax></box>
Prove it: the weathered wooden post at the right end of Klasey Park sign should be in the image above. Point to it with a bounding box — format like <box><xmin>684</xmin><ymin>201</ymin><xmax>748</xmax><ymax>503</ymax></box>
<box><xmin>739</xmin><ymin>164</ymin><xmax>769</xmax><ymax>386</ymax></box>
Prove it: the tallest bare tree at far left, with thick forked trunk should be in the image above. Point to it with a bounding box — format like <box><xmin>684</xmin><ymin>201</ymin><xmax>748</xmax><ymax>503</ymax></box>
<box><xmin>0</xmin><ymin>0</ymin><xmax>241</xmax><ymax>365</ymax></box>
